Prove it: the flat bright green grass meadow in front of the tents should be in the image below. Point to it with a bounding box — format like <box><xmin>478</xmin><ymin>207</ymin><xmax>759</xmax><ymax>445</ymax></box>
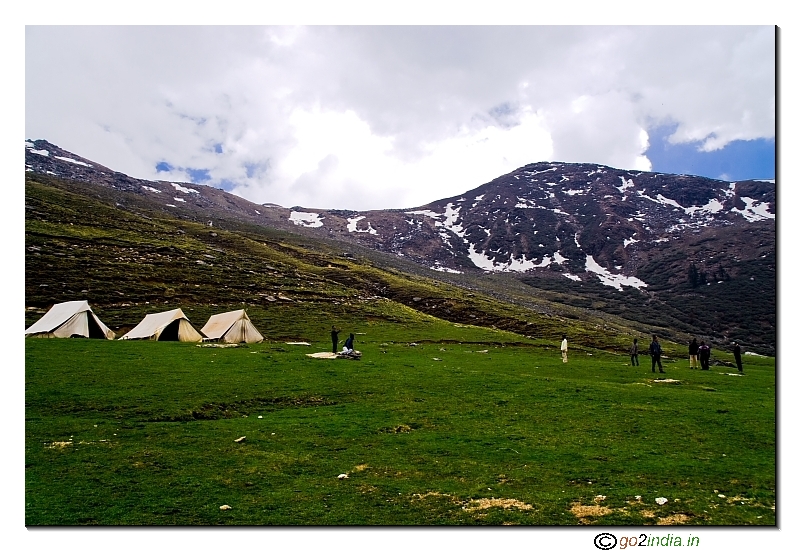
<box><xmin>25</xmin><ymin>314</ymin><xmax>776</xmax><ymax>525</ymax></box>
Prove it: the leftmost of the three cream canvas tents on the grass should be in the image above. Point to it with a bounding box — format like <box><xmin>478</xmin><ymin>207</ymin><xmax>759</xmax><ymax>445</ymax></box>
<box><xmin>25</xmin><ymin>300</ymin><xmax>114</xmax><ymax>340</ymax></box>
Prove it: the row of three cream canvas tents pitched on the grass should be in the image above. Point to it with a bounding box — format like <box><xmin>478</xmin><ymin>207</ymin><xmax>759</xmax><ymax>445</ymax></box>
<box><xmin>25</xmin><ymin>300</ymin><xmax>264</xmax><ymax>344</ymax></box>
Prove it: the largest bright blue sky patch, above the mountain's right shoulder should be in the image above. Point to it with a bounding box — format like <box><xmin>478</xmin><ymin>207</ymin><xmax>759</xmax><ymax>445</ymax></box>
<box><xmin>645</xmin><ymin>124</ymin><xmax>775</xmax><ymax>181</ymax></box>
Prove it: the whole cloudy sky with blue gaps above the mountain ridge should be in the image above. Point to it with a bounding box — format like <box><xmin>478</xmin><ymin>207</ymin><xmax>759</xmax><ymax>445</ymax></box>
<box><xmin>25</xmin><ymin>25</ymin><xmax>776</xmax><ymax>210</ymax></box>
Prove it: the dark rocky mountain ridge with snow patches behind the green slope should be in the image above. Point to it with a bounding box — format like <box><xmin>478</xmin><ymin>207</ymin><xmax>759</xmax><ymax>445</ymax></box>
<box><xmin>26</xmin><ymin>140</ymin><xmax>776</xmax><ymax>354</ymax></box>
